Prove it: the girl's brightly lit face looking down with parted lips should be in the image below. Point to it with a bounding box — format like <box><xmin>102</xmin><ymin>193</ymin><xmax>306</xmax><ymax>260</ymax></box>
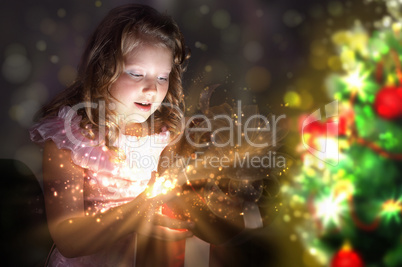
<box><xmin>110</xmin><ymin>44</ymin><xmax>173</xmax><ymax>124</ymax></box>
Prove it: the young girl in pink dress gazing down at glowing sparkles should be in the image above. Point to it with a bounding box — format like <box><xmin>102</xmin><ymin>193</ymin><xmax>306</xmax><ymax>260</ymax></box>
<box><xmin>30</xmin><ymin>4</ymin><xmax>193</xmax><ymax>266</ymax></box>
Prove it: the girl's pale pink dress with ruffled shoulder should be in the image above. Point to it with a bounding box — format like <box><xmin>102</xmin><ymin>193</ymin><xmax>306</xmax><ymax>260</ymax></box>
<box><xmin>30</xmin><ymin>107</ymin><xmax>169</xmax><ymax>266</ymax></box>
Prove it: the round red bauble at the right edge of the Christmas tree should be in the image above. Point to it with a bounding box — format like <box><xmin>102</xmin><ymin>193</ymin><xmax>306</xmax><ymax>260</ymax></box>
<box><xmin>374</xmin><ymin>86</ymin><xmax>402</xmax><ymax>120</ymax></box>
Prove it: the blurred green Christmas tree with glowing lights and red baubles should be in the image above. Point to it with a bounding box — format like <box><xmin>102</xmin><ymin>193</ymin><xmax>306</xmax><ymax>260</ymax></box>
<box><xmin>283</xmin><ymin>1</ymin><xmax>402</xmax><ymax>267</ymax></box>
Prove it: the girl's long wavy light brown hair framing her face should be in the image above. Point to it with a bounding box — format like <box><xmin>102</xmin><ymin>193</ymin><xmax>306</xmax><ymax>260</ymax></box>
<box><xmin>37</xmin><ymin>4</ymin><xmax>190</xmax><ymax>146</ymax></box>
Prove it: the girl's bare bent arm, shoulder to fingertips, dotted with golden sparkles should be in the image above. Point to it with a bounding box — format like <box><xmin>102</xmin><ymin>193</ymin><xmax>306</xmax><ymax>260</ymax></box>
<box><xmin>43</xmin><ymin>141</ymin><xmax>192</xmax><ymax>257</ymax></box>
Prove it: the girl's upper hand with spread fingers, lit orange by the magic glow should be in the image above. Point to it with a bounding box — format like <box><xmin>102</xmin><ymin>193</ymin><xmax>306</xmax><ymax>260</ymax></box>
<box><xmin>127</xmin><ymin>172</ymin><xmax>194</xmax><ymax>241</ymax></box>
